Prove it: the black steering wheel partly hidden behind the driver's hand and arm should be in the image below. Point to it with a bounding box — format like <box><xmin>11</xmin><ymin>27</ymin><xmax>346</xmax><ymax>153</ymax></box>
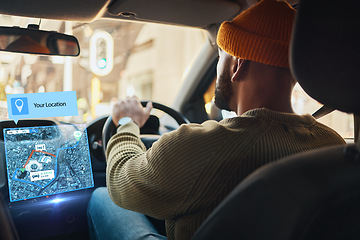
<box><xmin>102</xmin><ymin>101</ymin><xmax>190</xmax><ymax>152</ymax></box>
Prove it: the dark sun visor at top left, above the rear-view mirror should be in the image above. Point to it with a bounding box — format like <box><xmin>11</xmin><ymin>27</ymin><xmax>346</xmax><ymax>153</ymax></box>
<box><xmin>0</xmin><ymin>0</ymin><xmax>110</xmax><ymax>22</ymax></box>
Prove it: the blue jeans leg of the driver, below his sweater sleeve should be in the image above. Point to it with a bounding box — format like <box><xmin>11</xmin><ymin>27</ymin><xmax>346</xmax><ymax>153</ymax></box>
<box><xmin>88</xmin><ymin>187</ymin><xmax>166</xmax><ymax>240</ymax></box>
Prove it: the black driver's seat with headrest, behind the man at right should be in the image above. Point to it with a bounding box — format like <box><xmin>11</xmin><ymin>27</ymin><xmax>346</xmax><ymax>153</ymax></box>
<box><xmin>192</xmin><ymin>0</ymin><xmax>360</xmax><ymax>240</ymax></box>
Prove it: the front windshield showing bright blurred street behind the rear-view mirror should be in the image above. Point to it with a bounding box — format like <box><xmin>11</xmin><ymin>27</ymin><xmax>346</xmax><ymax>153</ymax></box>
<box><xmin>0</xmin><ymin>16</ymin><xmax>207</xmax><ymax>123</ymax></box>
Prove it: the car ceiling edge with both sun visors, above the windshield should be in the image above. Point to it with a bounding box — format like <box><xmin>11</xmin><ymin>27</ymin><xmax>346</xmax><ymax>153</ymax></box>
<box><xmin>0</xmin><ymin>0</ymin><xmax>294</xmax><ymax>28</ymax></box>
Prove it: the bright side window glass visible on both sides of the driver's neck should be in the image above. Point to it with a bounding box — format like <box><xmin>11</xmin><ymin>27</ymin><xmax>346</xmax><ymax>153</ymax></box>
<box><xmin>204</xmin><ymin>79</ymin><xmax>354</xmax><ymax>139</ymax></box>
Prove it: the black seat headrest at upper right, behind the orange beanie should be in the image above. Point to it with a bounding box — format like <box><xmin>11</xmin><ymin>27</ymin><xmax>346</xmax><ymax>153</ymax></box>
<box><xmin>290</xmin><ymin>0</ymin><xmax>360</xmax><ymax>114</ymax></box>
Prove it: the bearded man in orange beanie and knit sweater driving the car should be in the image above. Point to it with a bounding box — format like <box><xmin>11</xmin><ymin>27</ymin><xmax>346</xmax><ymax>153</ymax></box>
<box><xmin>88</xmin><ymin>0</ymin><xmax>344</xmax><ymax>239</ymax></box>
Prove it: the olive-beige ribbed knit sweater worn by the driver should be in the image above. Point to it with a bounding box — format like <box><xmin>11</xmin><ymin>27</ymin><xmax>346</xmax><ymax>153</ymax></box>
<box><xmin>106</xmin><ymin>109</ymin><xmax>345</xmax><ymax>240</ymax></box>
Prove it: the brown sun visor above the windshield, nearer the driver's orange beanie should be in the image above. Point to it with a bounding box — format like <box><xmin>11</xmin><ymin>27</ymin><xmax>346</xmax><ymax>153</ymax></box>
<box><xmin>108</xmin><ymin>0</ymin><xmax>240</xmax><ymax>27</ymax></box>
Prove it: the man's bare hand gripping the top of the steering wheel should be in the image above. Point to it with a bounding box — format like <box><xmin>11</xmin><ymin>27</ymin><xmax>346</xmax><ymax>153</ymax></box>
<box><xmin>112</xmin><ymin>96</ymin><xmax>152</xmax><ymax>128</ymax></box>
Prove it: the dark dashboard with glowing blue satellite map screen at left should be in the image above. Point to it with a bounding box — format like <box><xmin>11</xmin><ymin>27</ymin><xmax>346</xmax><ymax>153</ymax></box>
<box><xmin>0</xmin><ymin>118</ymin><xmax>102</xmax><ymax>239</ymax></box>
